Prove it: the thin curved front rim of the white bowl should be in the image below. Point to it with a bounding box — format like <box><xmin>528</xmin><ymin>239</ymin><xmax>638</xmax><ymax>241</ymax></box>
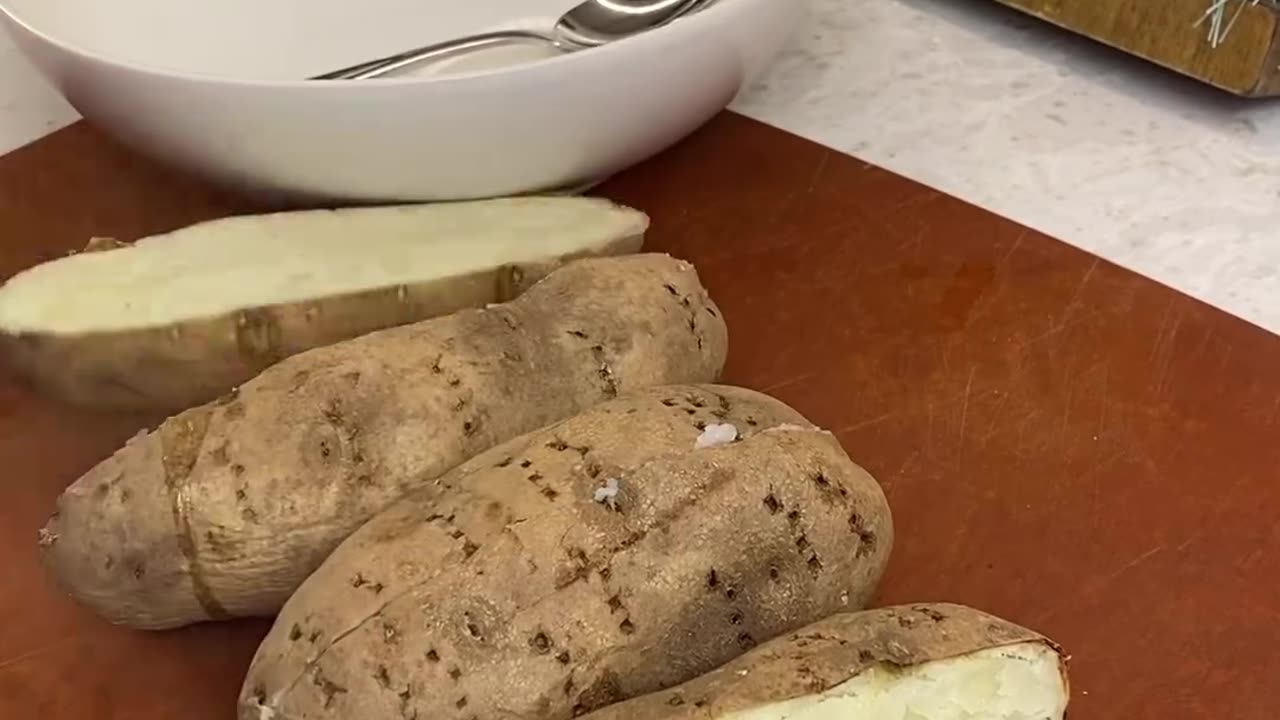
<box><xmin>0</xmin><ymin>0</ymin><xmax>757</xmax><ymax>87</ymax></box>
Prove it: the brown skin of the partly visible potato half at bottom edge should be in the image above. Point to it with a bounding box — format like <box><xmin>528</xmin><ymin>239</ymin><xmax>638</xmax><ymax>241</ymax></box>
<box><xmin>582</xmin><ymin>603</ymin><xmax>1066</xmax><ymax>720</ymax></box>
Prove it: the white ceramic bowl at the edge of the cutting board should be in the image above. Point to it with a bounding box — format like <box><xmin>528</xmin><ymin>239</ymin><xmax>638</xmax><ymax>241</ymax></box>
<box><xmin>0</xmin><ymin>0</ymin><xmax>804</xmax><ymax>201</ymax></box>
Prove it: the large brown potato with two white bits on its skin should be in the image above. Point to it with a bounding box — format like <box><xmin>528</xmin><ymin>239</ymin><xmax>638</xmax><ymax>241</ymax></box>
<box><xmin>241</xmin><ymin>388</ymin><xmax>892</xmax><ymax>720</ymax></box>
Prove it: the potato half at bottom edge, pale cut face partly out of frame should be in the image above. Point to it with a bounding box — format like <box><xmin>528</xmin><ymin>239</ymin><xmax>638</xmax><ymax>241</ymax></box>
<box><xmin>582</xmin><ymin>605</ymin><xmax>1069</xmax><ymax>720</ymax></box>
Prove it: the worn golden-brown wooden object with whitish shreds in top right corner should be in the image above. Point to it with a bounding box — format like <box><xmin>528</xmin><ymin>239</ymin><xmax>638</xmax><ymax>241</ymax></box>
<box><xmin>997</xmin><ymin>0</ymin><xmax>1280</xmax><ymax>97</ymax></box>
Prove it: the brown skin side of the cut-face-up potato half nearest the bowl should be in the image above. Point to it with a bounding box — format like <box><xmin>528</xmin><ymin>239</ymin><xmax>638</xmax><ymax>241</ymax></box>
<box><xmin>0</xmin><ymin>229</ymin><xmax>644</xmax><ymax>413</ymax></box>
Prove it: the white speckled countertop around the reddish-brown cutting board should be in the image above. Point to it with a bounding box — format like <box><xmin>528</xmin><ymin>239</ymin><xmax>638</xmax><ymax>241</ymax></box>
<box><xmin>0</xmin><ymin>0</ymin><xmax>1280</xmax><ymax>332</ymax></box>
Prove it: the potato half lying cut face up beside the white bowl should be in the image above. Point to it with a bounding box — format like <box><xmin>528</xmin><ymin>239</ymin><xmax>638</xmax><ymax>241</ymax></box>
<box><xmin>0</xmin><ymin>197</ymin><xmax>649</xmax><ymax>411</ymax></box>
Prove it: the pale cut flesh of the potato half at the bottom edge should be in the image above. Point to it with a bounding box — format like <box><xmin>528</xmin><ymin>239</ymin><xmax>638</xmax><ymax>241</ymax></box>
<box><xmin>719</xmin><ymin>643</ymin><xmax>1068</xmax><ymax>720</ymax></box>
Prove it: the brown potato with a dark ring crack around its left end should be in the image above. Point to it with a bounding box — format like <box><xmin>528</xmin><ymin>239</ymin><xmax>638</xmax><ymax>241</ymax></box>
<box><xmin>41</xmin><ymin>255</ymin><xmax>728</xmax><ymax>629</ymax></box>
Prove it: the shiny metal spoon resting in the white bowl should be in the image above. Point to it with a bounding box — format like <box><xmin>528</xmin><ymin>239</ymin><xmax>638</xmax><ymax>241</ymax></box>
<box><xmin>311</xmin><ymin>0</ymin><xmax>716</xmax><ymax>79</ymax></box>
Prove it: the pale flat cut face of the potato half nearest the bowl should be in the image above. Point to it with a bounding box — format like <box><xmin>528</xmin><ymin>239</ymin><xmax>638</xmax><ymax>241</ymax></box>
<box><xmin>0</xmin><ymin>197</ymin><xmax>649</xmax><ymax>334</ymax></box>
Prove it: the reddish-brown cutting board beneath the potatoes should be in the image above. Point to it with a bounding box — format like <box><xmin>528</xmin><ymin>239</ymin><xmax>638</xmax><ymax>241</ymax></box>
<box><xmin>0</xmin><ymin>115</ymin><xmax>1280</xmax><ymax>720</ymax></box>
